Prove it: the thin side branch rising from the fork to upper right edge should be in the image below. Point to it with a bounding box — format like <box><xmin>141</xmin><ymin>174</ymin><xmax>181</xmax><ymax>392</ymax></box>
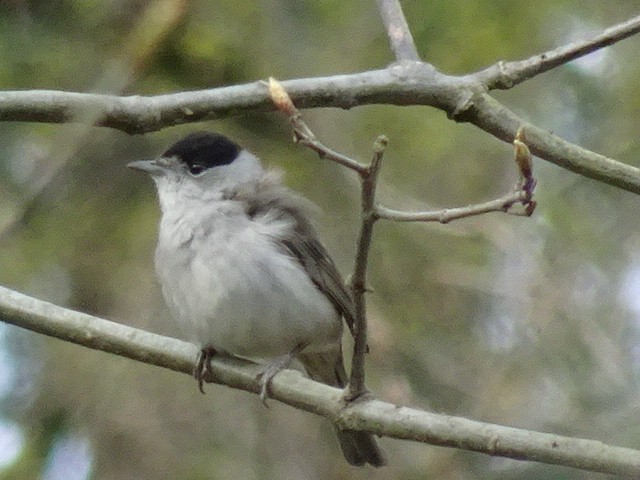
<box><xmin>473</xmin><ymin>16</ymin><xmax>640</xmax><ymax>90</ymax></box>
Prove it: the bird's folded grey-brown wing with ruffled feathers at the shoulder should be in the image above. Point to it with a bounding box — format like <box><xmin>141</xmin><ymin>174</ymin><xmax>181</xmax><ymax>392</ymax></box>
<box><xmin>231</xmin><ymin>177</ymin><xmax>355</xmax><ymax>337</ymax></box>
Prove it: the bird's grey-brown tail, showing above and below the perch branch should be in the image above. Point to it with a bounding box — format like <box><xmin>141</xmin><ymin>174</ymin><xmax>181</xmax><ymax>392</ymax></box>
<box><xmin>298</xmin><ymin>349</ymin><xmax>387</xmax><ymax>467</ymax></box>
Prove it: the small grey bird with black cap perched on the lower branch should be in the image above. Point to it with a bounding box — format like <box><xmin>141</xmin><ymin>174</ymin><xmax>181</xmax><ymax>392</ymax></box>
<box><xmin>129</xmin><ymin>132</ymin><xmax>385</xmax><ymax>467</ymax></box>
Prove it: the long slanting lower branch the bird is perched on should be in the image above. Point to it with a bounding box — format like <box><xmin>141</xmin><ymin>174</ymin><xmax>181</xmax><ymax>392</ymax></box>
<box><xmin>0</xmin><ymin>287</ymin><xmax>640</xmax><ymax>478</ymax></box>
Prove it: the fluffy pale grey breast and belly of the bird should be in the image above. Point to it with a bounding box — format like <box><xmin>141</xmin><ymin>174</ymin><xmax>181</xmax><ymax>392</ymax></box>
<box><xmin>156</xmin><ymin>201</ymin><xmax>341</xmax><ymax>357</ymax></box>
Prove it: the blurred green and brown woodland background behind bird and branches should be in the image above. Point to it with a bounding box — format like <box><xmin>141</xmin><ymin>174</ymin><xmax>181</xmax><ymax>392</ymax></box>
<box><xmin>0</xmin><ymin>0</ymin><xmax>640</xmax><ymax>480</ymax></box>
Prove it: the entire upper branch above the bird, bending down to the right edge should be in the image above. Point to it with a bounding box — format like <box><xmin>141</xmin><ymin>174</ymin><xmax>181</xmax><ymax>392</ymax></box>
<box><xmin>0</xmin><ymin>64</ymin><xmax>640</xmax><ymax>193</ymax></box>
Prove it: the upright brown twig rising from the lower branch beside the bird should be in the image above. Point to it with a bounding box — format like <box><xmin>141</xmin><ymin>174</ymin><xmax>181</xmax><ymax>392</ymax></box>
<box><xmin>347</xmin><ymin>136</ymin><xmax>387</xmax><ymax>399</ymax></box>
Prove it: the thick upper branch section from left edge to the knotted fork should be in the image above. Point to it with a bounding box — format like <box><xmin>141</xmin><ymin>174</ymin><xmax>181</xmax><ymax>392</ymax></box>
<box><xmin>0</xmin><ymin>64</ymin><xmax>456</xmax><ymax>134</ymax></box>
